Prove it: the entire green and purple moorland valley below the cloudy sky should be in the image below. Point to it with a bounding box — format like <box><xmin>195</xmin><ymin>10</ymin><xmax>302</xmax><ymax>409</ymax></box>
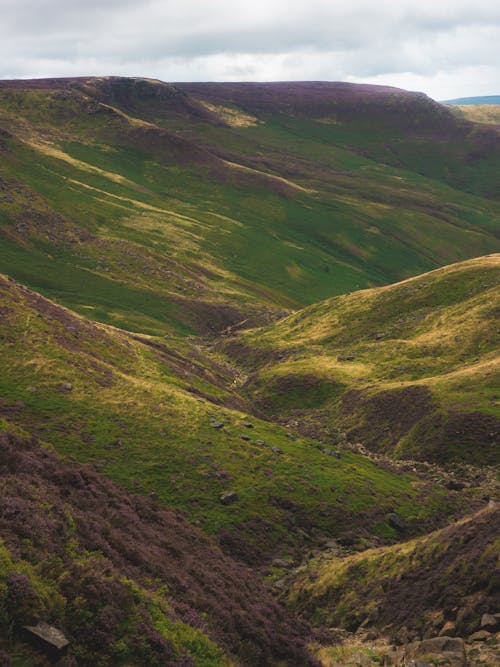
<box><xmin>0</xmin><ymin>77</ymin><xmax>500</xmax><ymax>667</ymax></box>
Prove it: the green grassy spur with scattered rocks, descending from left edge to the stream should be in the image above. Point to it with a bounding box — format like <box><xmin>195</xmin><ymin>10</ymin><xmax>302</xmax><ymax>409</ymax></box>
<box><xmin>0</xmin><ymin>278</ymin><xmax>464</xmax><ymax>566</ymax></box>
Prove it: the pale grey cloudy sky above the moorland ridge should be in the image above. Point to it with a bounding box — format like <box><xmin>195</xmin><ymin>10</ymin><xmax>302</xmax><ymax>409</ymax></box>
<box><xmin>0</xmin><ymin>0</ymin><xmax>500</xmax><ymax>100</ymax></box>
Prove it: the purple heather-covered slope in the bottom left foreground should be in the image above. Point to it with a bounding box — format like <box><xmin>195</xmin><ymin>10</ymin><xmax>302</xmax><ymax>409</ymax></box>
<box><xmin>0</xmin><ymin>421</ymin><xmax>310</xmax><ymax>667</ymax></box>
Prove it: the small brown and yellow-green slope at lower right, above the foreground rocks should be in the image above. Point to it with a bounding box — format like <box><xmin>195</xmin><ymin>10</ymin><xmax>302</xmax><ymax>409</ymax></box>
<box><xmin>288</xmin><ymin>507</ymin><xmax>500</xmax><ymax>638</ymax></box>
